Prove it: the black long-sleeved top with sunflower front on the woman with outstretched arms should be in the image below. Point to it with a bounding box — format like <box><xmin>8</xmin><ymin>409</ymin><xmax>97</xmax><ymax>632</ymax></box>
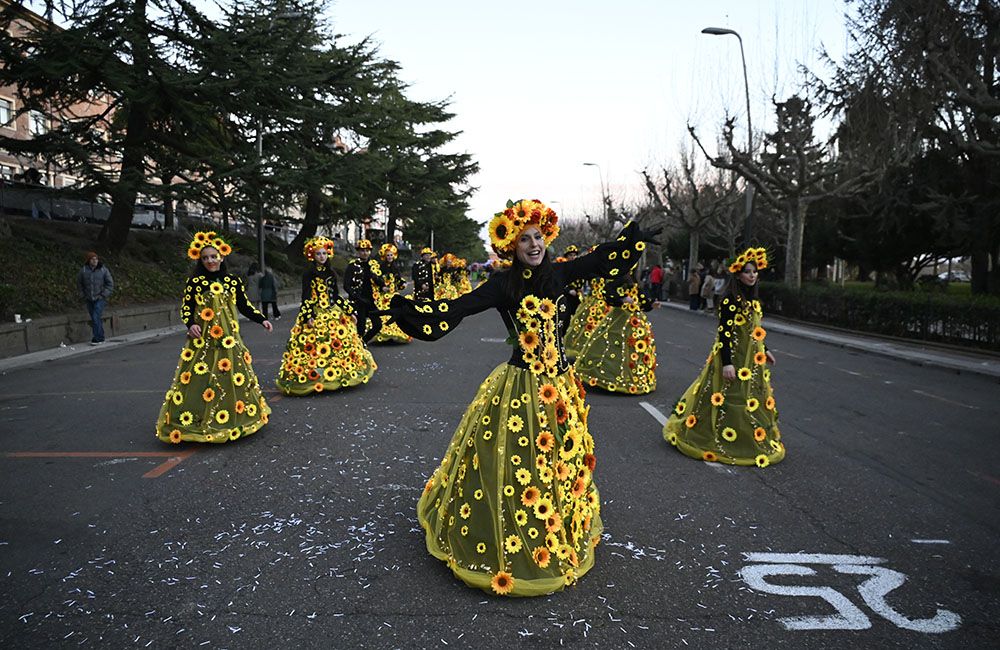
<box><xmin>389</xmin><ymin>224</ymin><xmax>645</xmax><ymax>374</ymax></box>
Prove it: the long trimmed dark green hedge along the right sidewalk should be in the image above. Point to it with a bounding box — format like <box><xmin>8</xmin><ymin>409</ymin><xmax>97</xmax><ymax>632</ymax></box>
<box><xmin>761</xmin><ymin>283</ymin><xmax>1000</xmax><ymax>351</ymax></box>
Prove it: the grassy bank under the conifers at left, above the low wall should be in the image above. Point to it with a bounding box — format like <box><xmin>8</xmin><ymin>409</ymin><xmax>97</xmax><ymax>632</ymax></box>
<box><xmin>0</xmin><ymin>218</ymin><xmax>299</xmax><ymax>321</ymax></box>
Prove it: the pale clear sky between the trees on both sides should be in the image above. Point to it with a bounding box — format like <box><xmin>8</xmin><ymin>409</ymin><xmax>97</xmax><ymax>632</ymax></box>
<box><xmin>329</xmin><ymin>0</ymin><xmax>847</xmax><ymax>233</ymax></box>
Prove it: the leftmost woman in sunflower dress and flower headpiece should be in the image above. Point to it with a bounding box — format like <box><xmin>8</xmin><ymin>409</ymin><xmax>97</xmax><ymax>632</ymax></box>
<box><xmin>156</xmin><ymin>232</ymin><xmax>272</xmax><ymax>443</ymax></box>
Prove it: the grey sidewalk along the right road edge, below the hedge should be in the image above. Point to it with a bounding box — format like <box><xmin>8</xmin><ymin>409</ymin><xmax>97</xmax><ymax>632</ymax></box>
<box><xmin>660</xmin><ymin>302</ymin><xmax>1000</xmax><ymax>380</ymax></box>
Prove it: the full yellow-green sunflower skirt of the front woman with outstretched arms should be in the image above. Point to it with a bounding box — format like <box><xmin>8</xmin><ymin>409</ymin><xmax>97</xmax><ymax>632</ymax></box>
<box><xmin>417</xmin><ymin>364</ymin><xmax>602</xmax><ymax>596</ymax></box>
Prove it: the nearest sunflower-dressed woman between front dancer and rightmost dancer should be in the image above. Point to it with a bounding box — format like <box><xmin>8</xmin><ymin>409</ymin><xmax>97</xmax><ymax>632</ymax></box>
<box><xmin>575</xmin><ymin>281</ymin><xmax>656</xmax><ymax>395</ymax></box>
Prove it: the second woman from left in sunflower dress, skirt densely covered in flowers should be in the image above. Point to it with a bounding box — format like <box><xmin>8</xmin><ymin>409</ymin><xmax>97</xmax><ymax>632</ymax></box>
<box><xmin>275</xmin><ymin>237</ymin><xmax>378</xmax><ymax>396</ymax></box>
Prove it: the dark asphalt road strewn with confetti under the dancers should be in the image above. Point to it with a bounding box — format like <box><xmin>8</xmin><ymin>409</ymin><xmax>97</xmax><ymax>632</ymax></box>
<box><xmin>0</xmin><ymin>302</ymin><xmax>1000</xmax><ymax>648</ymax></box>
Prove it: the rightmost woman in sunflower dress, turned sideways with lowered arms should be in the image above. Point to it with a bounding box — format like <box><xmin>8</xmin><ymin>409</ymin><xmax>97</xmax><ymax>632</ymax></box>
<box><xmin>663</xmin><ymin>248</ymin><xmax>785</xmax><ymax>467</ymax></box>
